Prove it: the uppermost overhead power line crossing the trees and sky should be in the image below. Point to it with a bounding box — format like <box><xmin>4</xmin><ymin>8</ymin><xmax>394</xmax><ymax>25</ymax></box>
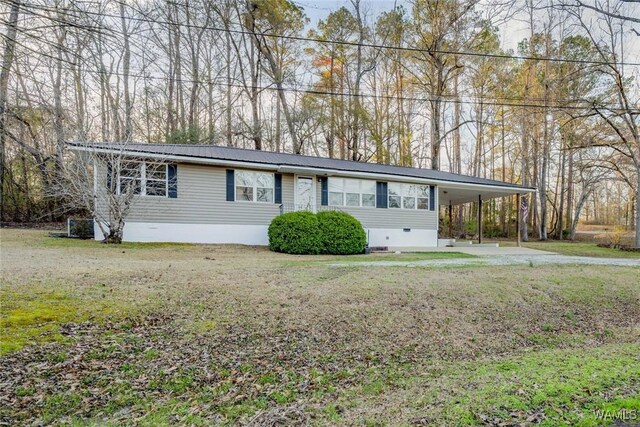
<box><xmin>9</xmin><ymin>0</ymin><xmax>640</xmax><ymax>67</ymax></box>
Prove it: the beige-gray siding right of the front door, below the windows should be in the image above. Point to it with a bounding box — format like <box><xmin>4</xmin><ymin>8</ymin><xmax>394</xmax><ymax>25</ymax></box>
<box><xmin>316</xmin><ymin>181</ymin><xmax>438</xmax><ymax>230</ymax></box>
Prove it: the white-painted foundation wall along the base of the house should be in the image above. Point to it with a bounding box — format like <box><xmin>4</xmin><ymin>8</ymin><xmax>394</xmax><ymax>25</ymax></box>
<box><xmin>94</xmin><ymin>222</ymin><xmax>438</xmax><ymax>249</ymax></box>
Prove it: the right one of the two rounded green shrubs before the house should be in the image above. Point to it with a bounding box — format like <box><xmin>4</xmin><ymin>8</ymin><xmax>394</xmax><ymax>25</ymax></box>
<box><xmin>317</xmin><ymin>211</ymin><xmax>367</xmax><ymax>255</ymax></box>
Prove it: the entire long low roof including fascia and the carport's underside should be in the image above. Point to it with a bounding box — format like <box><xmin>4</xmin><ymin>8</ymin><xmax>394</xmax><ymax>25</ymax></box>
<box><xmin>69</xmin><ymin>142</ymin><xmax>535</xmax><ymax>204</ymax></box>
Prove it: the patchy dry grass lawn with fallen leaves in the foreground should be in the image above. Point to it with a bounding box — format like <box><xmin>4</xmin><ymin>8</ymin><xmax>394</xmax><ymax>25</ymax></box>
<box><xmin>0</xmin><ymin>230</ymin><xmax>640</xmax><ymax>425</ymax></box>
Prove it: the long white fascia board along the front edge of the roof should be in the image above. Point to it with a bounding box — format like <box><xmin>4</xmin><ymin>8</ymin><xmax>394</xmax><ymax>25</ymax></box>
<box><xmin>71</xmin><ymin>145</ymin><xmax>536</xmax><ymax>194</ymax></box>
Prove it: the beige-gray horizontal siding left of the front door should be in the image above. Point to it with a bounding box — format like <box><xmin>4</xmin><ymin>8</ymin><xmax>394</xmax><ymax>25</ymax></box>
<box><xmin>98</xmin><ymin>163</ymin><xmax>293</xmax><ymax>225</ymax></box>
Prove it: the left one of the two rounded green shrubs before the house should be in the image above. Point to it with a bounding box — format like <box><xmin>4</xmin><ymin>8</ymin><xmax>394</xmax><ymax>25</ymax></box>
<box><xmin>269</xmin><ymin>211</ymin><xmax>322</xmax><ymax>254</ymax></box>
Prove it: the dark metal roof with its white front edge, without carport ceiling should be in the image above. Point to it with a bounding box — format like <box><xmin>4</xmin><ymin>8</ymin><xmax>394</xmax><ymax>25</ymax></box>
<box><xmin>69</xmin><ymin>143</ymin><xmax>534</xmax><ymax>190</ymax></box>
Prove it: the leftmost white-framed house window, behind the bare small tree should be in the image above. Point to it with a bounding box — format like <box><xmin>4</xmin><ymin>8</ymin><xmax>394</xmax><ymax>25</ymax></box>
<box><xmin>118</xmin><ymin>162</ymin><xmax>167</xmax><ymax>197</ymax></box>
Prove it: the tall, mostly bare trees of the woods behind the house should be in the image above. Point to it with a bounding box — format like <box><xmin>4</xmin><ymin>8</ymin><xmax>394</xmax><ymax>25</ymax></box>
<box><xmin>0</xmin><ymin>0</ymin><xmax>640</xmax><ymax>246</ymax></box>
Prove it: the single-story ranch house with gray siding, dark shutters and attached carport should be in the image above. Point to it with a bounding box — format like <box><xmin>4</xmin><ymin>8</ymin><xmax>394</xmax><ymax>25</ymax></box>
<box><xmin>69</xmin><ymin>143</ymin><xmax>535</xmax><ymax>249</ymax></box>
